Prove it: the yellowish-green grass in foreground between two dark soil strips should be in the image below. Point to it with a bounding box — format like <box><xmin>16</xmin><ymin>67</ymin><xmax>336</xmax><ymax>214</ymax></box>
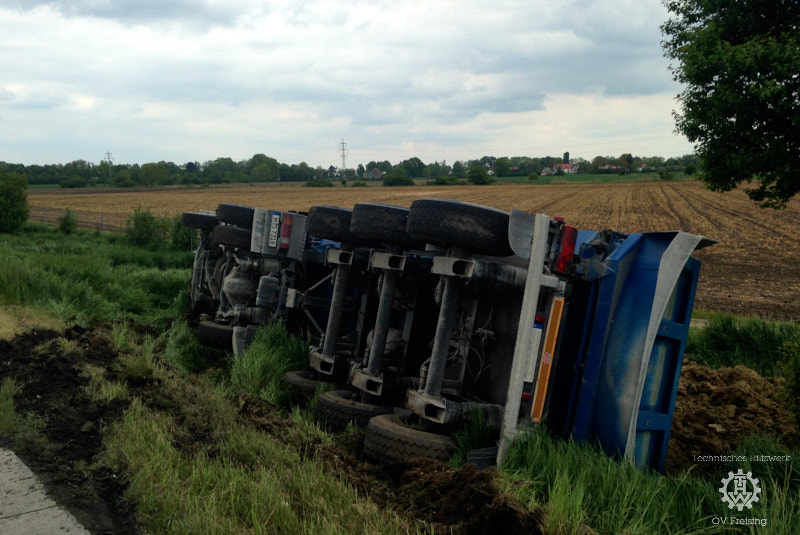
<box><xmin>105</xmin><ymin>383</ymin><xmax>417</xmax><ymax>534</ymax></box>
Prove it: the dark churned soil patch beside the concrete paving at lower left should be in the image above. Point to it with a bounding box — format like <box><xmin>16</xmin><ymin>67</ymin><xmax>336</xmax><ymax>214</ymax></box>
<box><xmin>0</xmin><ymin>327</ymin><xmax>139</xmax><ymax>534</ymax></box>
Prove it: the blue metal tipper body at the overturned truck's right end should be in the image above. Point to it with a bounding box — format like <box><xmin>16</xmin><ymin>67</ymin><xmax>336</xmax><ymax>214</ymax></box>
<box><xmin>572</xmin><ymin>233</ymin><xmax>699</xmax><ymax>470</ymax></box>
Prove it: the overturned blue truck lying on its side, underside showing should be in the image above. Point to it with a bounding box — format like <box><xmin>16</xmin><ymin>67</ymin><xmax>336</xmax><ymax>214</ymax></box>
<box><xmin>183</xmin><ymin>199</ymin><xmax>713</xmax><ymax>470</ymax></box>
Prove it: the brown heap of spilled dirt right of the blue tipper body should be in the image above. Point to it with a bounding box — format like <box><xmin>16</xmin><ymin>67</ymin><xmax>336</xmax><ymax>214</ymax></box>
<box><xmin>667</xmin><ymin>360</ymin><xmax>798</xmax><ymax>473</ymax></box>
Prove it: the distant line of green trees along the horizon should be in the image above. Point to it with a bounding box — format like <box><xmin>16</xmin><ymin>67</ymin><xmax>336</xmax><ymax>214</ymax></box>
<box><xmin>0</xmin><ymin>153</ymin><xmax>698</xmax><ymax>188</ymax></box>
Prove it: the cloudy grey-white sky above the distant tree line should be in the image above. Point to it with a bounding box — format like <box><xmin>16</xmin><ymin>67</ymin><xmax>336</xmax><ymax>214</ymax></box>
<box><xmin>0</xmin><ymin>0</ymin><xmax>693</xmax><ymax>167</ymax></box>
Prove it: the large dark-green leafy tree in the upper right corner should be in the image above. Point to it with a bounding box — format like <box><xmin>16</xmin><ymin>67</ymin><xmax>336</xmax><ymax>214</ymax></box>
<box><xmin>661</xmin><ymin>0</ymin><xmax>800</xmax><ymax>208</ymax></box>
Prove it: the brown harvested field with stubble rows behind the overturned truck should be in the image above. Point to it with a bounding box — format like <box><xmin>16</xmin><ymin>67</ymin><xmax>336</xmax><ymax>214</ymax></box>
<box><xmin>28</xmin><ymin>182</ymin><xmax>800</xmax><ymax>321</ymax></box>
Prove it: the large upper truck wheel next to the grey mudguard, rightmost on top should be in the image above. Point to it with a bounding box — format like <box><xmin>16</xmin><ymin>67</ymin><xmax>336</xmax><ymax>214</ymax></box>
<box><xmin>407</xmin><ymin>199</ymin><xmax>512</xmax><ymax>256</ymax></box>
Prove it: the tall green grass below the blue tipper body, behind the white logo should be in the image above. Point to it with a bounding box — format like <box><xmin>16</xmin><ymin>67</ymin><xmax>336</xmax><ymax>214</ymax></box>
<box><xmin>503</xmin><ymin>428</ymin><xmax>800</xmax><ymax>534</ymax></box>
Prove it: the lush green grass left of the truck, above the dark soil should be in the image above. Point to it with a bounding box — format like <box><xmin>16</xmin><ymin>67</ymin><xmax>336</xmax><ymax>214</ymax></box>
<box><xmin>0</xmin><ymin>224</ymin><xmax>192</xmax><ymax>328</ymax></box>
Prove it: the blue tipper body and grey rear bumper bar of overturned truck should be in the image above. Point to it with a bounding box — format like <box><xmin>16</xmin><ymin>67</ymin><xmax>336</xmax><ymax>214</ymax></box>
<box><xmin>497</xmin><ymin>211</ymin><xmax>714</xmax><ymax>471</ymax></box>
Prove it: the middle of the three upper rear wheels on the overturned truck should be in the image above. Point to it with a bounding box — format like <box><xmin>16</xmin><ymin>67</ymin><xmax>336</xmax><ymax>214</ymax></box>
<box><xmin>350</xmin><ymin>202</ymin><xmax>425</xmax><ymax>249</ymax></box>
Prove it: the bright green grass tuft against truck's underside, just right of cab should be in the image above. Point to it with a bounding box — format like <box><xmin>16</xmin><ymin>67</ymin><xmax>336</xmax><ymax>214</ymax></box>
<box><xmin>230</xmin><ymin>322</ymin><xmax>308</xmax><ymax>405</ymax></box>
